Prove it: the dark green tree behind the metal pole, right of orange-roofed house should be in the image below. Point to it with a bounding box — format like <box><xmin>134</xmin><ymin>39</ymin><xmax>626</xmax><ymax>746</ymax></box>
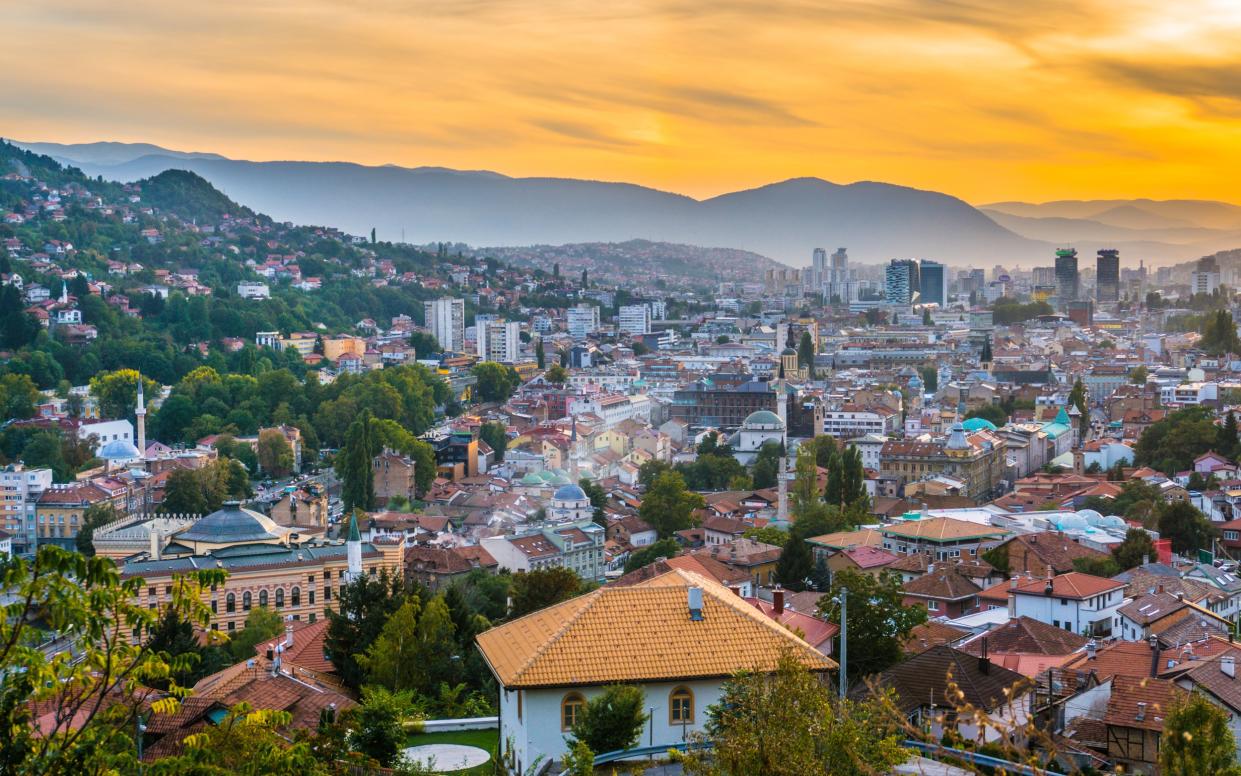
<box><xmin>819</xmin><ymin>569</ymin><xmax>927</xmax><ymax>682</ymax></box>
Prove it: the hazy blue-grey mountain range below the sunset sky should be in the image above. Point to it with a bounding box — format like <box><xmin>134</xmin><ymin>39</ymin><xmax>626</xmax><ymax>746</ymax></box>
<box><xmin>16</xmin><ymin>143</ymin><xmax>1241</xmax><ymax>266</ymax></box>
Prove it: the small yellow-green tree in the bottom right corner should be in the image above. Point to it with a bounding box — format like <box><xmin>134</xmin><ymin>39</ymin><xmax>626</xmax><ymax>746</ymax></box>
<box><xmin>1159</xmin><ymin>693</ymin><xmax>1241</xmax><ymax>776</ymax></box>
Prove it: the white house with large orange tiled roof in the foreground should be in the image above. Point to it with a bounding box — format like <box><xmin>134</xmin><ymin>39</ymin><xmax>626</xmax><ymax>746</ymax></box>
<box><xmin>478</xmin><ymin>569</ymin><xmax>836</xmax><ymax>774</ymax></box>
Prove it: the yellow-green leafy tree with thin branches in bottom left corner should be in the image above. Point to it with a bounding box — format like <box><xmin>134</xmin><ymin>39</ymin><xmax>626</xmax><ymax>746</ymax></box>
<box><xmin>0</xmin><ymin>545</ymin><xmax>225</xmax><ymax>776</ymax></box>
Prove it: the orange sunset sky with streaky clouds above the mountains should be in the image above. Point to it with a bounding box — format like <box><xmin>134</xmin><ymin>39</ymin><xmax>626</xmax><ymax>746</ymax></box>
<box><xmin>7</xmin><ymin>0</ymin><xmax>1241</xmax><ymax>204</ymax></box>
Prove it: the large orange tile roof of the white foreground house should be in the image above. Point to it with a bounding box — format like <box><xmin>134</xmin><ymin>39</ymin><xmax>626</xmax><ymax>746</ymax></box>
<box><xmin>478</xmin><ymin>569</ymin><xmax>836</xmax><ymax>688</ymax></box>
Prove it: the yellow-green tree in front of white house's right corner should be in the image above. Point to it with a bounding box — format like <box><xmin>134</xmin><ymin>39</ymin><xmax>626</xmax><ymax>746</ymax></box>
<box><xmin>673</xmin><ymin>653</ymin><xmax>908</xmax><ymax>776</ymax></box>
